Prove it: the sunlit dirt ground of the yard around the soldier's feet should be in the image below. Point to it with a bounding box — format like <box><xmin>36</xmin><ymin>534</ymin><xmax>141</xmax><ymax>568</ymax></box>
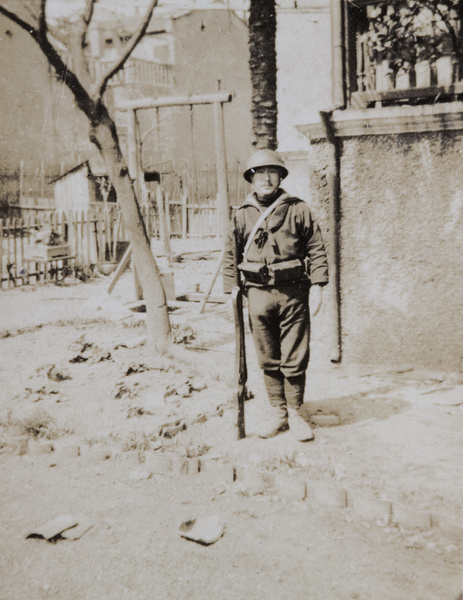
<box><xmin>0</xmin><ymin>240</ymin><xmax>463</xmax><ymax>600</ymax></box>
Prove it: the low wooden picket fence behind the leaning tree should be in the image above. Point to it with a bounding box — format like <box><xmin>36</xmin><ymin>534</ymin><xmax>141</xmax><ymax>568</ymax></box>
<box><xmin>0</xmin><ymin>194</ymin><xmax>219</xmax><ymax>289</ymax></box>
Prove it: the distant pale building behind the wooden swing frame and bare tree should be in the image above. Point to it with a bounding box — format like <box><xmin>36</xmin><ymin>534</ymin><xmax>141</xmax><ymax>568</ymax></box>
<box><xmin>0</xmin><ymin>5</ymin><xmax>251</xmax><ymax>200</ymax></box>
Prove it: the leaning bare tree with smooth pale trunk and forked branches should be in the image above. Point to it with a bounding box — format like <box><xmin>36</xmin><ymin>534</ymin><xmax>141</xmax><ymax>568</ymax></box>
<box><xmin>0</xmin><ymin>0</ymin><xmax>171</xmax><ymax>352</ymax></box>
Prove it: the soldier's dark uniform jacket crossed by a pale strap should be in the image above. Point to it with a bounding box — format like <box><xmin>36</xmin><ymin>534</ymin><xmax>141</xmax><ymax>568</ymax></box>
<box><xmin>223</xmin><ymin>189</ymin><xmax>328</xmax><ymax>293</ymax></box>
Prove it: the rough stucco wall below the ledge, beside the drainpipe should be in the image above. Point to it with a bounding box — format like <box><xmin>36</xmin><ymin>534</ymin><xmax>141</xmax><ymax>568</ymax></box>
<box><xmin>310</xmin><ymin>132</ymin><xmax>463</xmax><ymax>371</ymax></box>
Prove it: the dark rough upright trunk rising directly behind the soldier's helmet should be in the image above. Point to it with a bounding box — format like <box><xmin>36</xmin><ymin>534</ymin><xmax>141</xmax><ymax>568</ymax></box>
<box><xmin>249</xmin><ymin>0</ymin><xmax>278</xmax><ymax>150</ymax></box>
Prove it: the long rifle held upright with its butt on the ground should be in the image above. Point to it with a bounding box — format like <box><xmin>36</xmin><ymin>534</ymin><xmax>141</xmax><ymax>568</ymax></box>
<box><xmin>232</xmin><ymin>228</ymin><xmax>248</xmax><ymax>440</ymax></box>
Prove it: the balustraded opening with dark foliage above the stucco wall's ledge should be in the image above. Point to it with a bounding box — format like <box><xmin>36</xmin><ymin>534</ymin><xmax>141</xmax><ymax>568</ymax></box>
<box><xmin>344</xmin><ymin>0</ymin><xmax>463</xmax><ymax>108</ymax></box>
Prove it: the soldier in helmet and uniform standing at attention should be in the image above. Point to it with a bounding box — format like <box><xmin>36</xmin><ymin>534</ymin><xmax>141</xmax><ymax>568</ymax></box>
<box><xmin>223</xmin><ymin>150</ymin><xmax>328</xmax><ymax>441</ymax></box>
